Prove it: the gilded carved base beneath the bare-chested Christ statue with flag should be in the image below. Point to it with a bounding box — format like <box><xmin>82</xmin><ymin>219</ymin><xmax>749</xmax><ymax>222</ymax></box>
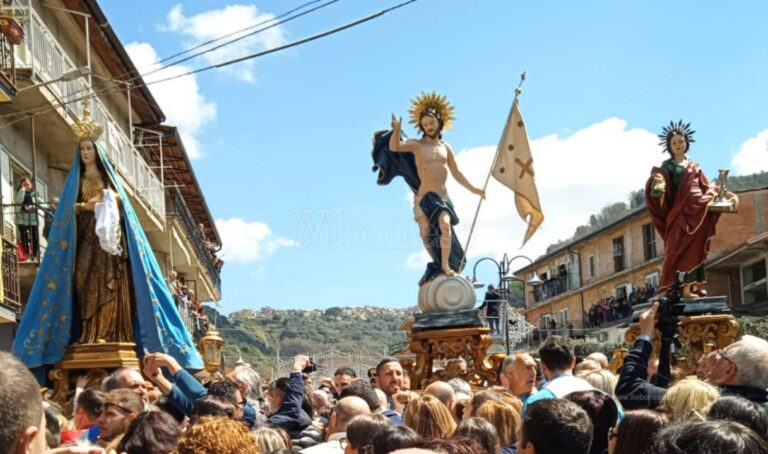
<box><xmin>402</xmin><ymin>327</ymin><xmax>504</xmax><ymax>389</ymax></box>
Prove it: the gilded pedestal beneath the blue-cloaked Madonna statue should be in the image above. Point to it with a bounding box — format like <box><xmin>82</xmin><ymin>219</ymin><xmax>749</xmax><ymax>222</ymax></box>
<box><xmin>48</xmin><ymin>342</ymin><xmax>141</xmax><ymax>403</ymax></box>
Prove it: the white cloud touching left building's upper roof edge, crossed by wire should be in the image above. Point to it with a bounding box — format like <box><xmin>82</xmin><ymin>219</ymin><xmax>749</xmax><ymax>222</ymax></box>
<box><xmin>125</xmin><ymin>43</ymin><xmax>216</xmax><ymax>159</ymax></box>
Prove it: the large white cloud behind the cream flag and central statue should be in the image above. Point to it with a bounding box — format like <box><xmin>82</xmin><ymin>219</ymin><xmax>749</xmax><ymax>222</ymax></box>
<box><xmin>406</xmin><ymin>118</ymin><xmax>664</xmax><ymax>269</ymax></box>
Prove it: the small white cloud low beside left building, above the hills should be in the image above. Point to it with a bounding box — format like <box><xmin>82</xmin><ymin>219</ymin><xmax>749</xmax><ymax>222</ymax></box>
<box><xmin>216</xmin><ymin>218</ymin><xmax>298</xmax><ymax>264</ymax></box>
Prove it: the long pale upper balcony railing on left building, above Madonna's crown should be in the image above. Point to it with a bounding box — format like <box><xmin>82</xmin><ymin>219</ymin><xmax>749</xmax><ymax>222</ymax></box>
<box><xmin>9</xmin><ymin>4</ymin><xmax>165</xmax><ymax>220</ymax></box>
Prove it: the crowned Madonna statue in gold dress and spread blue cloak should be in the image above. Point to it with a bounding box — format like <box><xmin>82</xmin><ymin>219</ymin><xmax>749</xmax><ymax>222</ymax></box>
<box><xmin>13</xmin><ymin>108</ymin><xmax>202</xmax><ymax>376</ymax></box>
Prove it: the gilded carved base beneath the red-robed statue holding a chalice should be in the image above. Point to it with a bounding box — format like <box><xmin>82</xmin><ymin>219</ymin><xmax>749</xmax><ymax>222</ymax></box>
<box><xmin>624</xmin><ymin>314</ymin><xmax>739</xmax><ymax>375</ymax></box>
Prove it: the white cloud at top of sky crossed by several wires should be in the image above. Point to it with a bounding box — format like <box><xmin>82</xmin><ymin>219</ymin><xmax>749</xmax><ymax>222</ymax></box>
<box><xmin>165</xmin><ymin>4</ymin><xmax>285</xmax><ymax>82</ymax></box>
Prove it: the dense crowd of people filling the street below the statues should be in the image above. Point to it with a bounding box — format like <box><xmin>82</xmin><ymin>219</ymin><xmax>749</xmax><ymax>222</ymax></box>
<box><xmin>0</xmin><ymin>303</ymin><xmax>768</xmax><ymax>454</ymax></box>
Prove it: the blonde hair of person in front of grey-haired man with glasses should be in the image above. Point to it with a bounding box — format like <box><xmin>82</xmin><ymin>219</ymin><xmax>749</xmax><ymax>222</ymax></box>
<box><xmin>659</xmin><ymin>378</ymin><xmax>720</xmax><ymax>422</ymax></box>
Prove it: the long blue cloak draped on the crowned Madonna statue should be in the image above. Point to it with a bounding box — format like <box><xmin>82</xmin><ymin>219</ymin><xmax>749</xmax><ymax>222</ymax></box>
<box><xmin>13</xmin><ymin>146</ymin><xmax>203</xmax><ymax>382</ymax></box>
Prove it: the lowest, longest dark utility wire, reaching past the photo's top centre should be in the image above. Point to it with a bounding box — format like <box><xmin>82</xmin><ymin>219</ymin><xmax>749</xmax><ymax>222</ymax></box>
<box><xmin>0</xmin><ymin>0</ymin><xmax>418</xmax><ymax>130</ymax></box>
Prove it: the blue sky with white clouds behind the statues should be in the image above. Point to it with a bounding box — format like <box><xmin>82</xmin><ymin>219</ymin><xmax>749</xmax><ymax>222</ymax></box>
<box><xmin>101</xmin><ymin>0</ymin><xmax>768</xmax><ymax>313</ymax></box>
